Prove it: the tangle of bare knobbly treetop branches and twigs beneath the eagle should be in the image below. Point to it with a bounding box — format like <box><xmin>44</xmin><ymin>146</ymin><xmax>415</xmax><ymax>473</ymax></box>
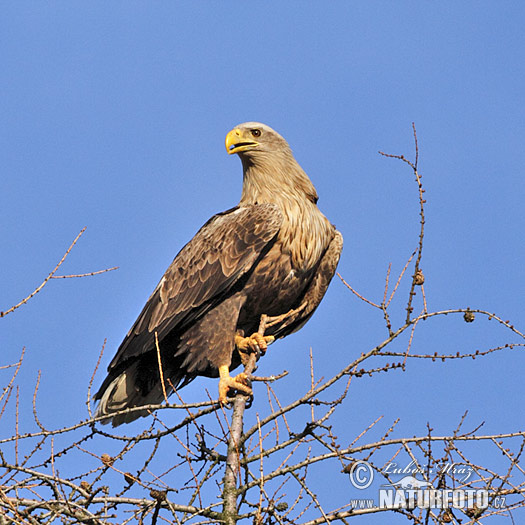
<box><xmin>0</xmin><ymin>126</ymin><xmax>525</xmax><ymax>525</ymax></box>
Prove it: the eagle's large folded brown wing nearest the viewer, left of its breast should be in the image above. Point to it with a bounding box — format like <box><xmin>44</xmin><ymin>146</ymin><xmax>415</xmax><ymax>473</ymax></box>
<box><xmin>108</xmin><ymin>204</ymin><xmax>282</xmax><ymax>370</ymax></box>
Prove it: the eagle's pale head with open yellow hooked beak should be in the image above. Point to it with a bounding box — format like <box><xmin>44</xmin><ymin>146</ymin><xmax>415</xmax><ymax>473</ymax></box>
<box><xmin>225</xmin><ymin>122</ymin><xmax>291</xmax><ymax>158</ymax></box>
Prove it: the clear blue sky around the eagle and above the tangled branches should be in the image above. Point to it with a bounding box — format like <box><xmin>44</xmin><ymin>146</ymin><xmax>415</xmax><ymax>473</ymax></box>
<box><xmin>0</xmin><ymin>0</ymin><xmax>525</xmax><ymax>523</ymax></box>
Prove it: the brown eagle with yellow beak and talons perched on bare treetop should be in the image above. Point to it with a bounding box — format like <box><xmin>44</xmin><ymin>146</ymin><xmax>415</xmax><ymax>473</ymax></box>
<box><xmin>95</xmin><ymin>122</ymin><xmax>343</xmax><ymax>426</ymax></box>
